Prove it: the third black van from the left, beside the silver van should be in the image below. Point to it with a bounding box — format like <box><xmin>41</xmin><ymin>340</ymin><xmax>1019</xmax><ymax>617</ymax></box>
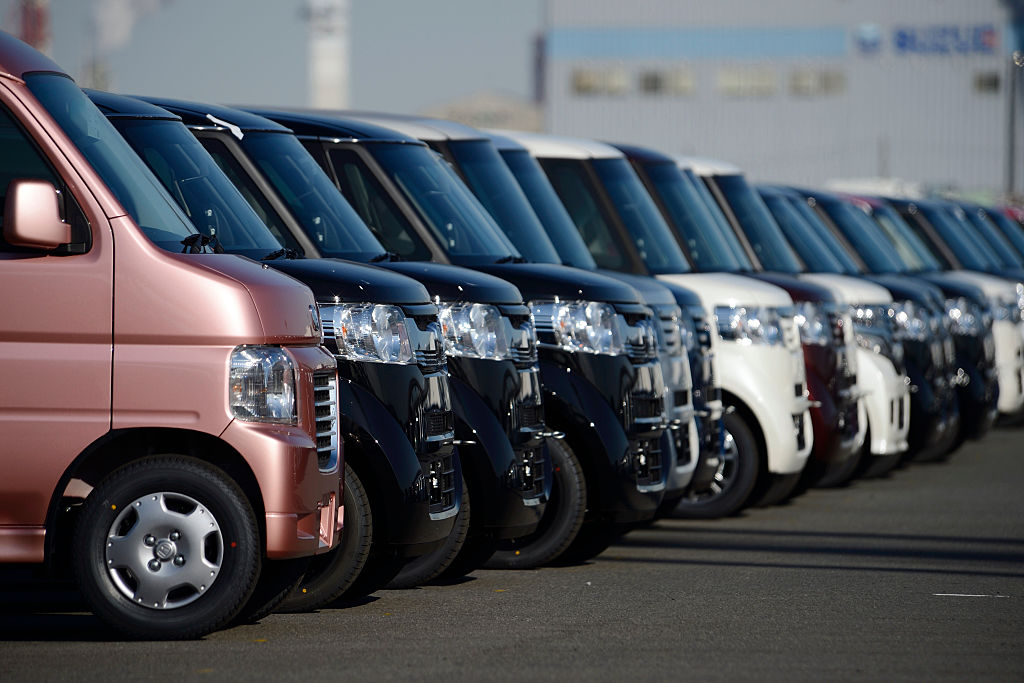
<box><xmin>246</xmin><ymin>112</ymin><xmax>668</xmax><ymax>567</ymax></box>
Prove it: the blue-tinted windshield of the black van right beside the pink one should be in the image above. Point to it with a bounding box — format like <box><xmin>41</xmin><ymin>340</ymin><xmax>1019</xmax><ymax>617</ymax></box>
<box><xmin>113</xmin><ymin>119</ymin><xmax>281</xmax><ymax>259</ymax></box>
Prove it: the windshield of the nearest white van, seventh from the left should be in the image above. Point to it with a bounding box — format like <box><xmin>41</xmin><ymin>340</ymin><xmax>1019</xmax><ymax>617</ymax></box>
<box><xmin>592</xmin><ymin>159</ymin><xmax>690</xmax><ymax>274</ymax></box>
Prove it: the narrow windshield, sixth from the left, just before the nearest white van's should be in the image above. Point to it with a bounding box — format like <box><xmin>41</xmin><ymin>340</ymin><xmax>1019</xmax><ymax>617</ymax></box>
<box><xmin>501</xmin><ymin>150</ymin><xmax>597</xmax><ymax>270</ymax></box>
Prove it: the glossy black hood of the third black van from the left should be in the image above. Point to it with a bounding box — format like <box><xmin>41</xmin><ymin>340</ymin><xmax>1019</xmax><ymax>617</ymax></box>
<box><xmin>478</xmin><ymin>263</ymin><xmax>641</xmax><ymax>303</ymax></box>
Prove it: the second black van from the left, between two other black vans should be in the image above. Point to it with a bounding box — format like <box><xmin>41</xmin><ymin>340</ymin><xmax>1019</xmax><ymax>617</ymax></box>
<box><xmin>133</xmin><ymin>99</ymin><xmax>558</xmax><ymax>577</ymax></box>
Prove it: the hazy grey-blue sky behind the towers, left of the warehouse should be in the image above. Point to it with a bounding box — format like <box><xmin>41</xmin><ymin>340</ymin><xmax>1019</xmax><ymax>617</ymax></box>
<box><xmin>0</xmin><ymin>0</ymin><xmax>544</xmax><ymax>113</ymax></box>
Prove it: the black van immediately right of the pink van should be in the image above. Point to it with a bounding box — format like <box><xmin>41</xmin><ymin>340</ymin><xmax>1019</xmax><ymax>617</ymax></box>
<box><xmin>92</xmin><ymin>93</ymin><xmax>546</xmax><ymax>608</ymax></box>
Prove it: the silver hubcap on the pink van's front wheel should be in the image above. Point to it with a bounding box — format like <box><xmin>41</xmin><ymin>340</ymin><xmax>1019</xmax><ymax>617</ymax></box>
<box><xmin>103</xmin><ymin>492</ymin><xmax>224</xmax><ymax>609</ymax></box>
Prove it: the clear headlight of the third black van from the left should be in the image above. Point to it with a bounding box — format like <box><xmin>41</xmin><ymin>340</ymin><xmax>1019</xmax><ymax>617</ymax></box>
<box><xmin>529</xmin><ymin>301</ymin><xmax>626</xmax><ymax>355</ymax></box>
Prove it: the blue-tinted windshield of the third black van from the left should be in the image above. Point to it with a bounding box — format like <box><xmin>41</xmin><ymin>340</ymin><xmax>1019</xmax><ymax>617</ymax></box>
<box><xmin>368</xmin><ymin>144</ymin><xmax>519</xmax><ymax>265</ymax></box>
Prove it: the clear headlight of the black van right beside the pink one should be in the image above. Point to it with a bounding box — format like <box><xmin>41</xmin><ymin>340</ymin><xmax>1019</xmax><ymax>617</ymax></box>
<box><xmin>332</xmin><ymin>303</ymin><xmax>415</xmax><ymax>365</ymax></box>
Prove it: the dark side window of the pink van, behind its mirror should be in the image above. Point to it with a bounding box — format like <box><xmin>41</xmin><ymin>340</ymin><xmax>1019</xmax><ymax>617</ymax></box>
<box><xmin>0</xmin><ymin>108</ymin><xmax>89</xmax><ymax>253</ymax></box>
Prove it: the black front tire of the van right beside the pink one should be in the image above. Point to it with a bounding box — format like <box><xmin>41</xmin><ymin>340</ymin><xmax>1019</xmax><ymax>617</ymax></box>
<box><xmin>279</xmin><ymin>464</ymin><xmax>373</xmax><ymax>612</ymax></box>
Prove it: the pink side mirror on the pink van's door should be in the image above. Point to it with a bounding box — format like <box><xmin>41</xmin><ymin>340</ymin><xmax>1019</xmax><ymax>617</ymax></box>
<box><xmin>3</xmin><ymin>178</ymin><xmax>71</xmax><ymax>250</ymax></box>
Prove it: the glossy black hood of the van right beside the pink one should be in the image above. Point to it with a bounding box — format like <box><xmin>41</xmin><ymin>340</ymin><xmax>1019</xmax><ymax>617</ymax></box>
<box><xmin>265</xmin><ymin>258</ymin><xmax>430</xmax><ymax>304</ymax></box>
